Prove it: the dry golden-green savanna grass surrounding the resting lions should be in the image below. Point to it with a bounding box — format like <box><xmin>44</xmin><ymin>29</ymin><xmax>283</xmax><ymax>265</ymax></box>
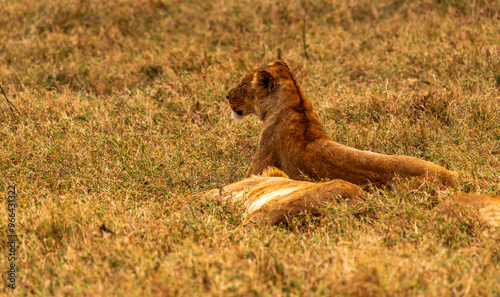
<box><xmin>0</xmin><ymin>0</ymin><xmax>500</xmax><ymax>296</ymax></box>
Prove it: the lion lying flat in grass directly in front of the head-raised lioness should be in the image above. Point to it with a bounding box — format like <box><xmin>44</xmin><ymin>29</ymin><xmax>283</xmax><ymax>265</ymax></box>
<box><xmin>205</xmin><ymin>168</ymin><xmax>366</xmax><ymax>225</ymax></box>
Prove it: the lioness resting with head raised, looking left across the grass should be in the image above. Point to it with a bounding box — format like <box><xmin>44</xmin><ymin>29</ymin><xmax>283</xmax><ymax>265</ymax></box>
<box><xmin>226</xmin><ymin>61</ymin><xmax>458</xmax><ymax>187</ymax></box>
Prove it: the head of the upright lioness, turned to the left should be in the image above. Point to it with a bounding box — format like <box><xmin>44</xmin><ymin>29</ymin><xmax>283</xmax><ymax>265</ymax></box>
<box><xmin>226</xmin><ymin>60</ymin><xmax>298</xmax><ymax>121</ymax></box>
